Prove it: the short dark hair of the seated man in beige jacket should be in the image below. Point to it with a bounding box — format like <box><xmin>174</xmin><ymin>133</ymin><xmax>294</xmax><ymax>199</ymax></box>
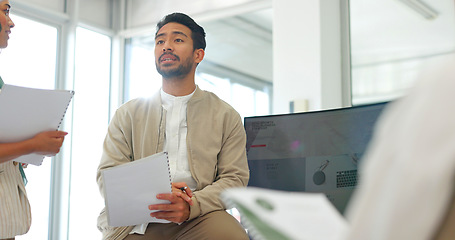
<box><xmin>155</xmin><ymin>13</ymin><xmax>206</xmax><ymax>50</ymax></box>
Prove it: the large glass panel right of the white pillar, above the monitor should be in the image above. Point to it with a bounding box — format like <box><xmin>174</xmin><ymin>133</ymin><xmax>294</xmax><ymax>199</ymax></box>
<box><xmin>350</xmin><ymin>0</ymin><xmax>455</xmax><ymax>105</ymax></box>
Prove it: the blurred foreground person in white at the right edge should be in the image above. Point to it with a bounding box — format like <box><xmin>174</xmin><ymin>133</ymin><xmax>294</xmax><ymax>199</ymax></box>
<box><xmin>345</xmin><ymin>54</ymin><xmax>455</xmax><ymax>240</ymax></box>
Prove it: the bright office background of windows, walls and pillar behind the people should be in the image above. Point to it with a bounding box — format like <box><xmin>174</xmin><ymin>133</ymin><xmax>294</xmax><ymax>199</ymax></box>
<box><xmin>0</xmin><ymin>0</ymin><xmax>455</xmax><ymax>240</ymax></box>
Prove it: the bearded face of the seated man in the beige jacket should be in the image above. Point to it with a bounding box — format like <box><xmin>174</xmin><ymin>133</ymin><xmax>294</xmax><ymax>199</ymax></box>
<box><xmin>155</xmin><ymin>22</ymin><xmax>199</xmax><ymax>78</ymax></box>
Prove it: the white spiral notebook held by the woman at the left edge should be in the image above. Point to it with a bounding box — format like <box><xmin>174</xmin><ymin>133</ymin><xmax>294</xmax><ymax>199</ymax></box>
<box><xmin>0</xmin><ymin>84</ymin><xmax>74</xmax><ymax>165</ymax></box>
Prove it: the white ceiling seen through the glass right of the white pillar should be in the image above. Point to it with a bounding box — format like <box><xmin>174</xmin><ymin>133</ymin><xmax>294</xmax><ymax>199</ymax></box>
<box><xmin>350</xmin><ymin>0</ymin><xmax>455</xmax><ymax>66</ymax></box>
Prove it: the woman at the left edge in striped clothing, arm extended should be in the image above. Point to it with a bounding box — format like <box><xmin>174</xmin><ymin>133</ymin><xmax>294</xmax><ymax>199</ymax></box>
<box><xmin>0</xmin><ymin>0</ymin><xmax>67</xmax><ymax>239</ymax></box>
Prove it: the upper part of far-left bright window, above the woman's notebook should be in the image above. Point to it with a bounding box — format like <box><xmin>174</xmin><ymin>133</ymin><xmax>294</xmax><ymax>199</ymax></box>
<box><xmin>0</xmin><ymin>14</ymin><xmax>57</xmax><ymax>89</ymax></box>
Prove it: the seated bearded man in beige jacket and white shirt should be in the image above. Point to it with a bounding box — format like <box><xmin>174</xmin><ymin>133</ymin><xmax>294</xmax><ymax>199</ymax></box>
<box><xmin>97</xmin><ymin>13</ymin><xmax>249</xmax><ymax>240</ymax></box>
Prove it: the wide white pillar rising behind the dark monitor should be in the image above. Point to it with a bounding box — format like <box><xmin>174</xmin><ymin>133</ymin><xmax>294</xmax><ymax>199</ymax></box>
<box><xmin>273</xmin><ymin>0</ymin><xmax>342</xmax><ymax>114</ymax></box>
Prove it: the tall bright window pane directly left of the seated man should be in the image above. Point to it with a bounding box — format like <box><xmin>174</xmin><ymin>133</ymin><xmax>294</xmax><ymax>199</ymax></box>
<box><xmin>69</xmin><ymin>28</ymin><xmax>111</xmax><ymax>239</ymax></box>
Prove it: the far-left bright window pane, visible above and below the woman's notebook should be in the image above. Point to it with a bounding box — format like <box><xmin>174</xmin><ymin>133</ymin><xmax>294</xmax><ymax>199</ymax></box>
<box><xmin>0</xmin><ymin>14</ymin><xmax>57</xmax><ymax>240</ymax></box>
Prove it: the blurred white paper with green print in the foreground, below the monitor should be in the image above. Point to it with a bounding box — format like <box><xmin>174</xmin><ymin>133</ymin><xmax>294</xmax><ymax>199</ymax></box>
<box><xmin>221</xmin><ymin>187</ymin><xmax>348</xmax><ymax>240</ymax></box>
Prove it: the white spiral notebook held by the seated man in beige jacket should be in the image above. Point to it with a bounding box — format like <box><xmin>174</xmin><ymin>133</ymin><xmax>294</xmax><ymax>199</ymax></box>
<box><xmin>102</xmin><ymin>152</ymin><xmax>172</xmax><ymax>227</ymax></box>
